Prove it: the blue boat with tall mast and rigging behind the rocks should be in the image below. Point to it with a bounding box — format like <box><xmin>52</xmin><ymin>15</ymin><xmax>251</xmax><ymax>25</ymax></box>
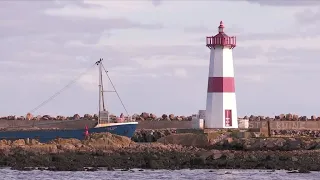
<box><xmin>0</xmin><ymin>58</ymin><xmax>138</xmax><ymax>143</ymax></box>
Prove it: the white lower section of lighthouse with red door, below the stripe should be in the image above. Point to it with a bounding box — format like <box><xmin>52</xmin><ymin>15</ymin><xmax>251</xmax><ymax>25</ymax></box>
<box><xmin>205</xmin><ymin>93</ymin><xmax>238</xmax><ymax>129</ymax></box>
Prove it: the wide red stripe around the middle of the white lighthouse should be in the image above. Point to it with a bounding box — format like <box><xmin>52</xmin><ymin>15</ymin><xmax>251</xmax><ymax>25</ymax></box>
<box><xmin>208</xmin><ymin>77</ymin><xmax>235</xmax><ymax>93</ymax></box>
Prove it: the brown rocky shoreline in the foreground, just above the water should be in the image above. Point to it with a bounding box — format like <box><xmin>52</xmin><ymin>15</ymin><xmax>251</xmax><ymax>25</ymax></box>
<box><xmin>0</xmin><ymin>132</ymin><xmax>320</xmax><ymax>172</ymax></box>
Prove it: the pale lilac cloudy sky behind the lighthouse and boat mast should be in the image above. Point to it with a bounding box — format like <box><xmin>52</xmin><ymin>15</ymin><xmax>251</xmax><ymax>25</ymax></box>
<box><xmin>0</xmin><ymin>0</ymin><xmax>320</xmax><ymax>117</ymax></box>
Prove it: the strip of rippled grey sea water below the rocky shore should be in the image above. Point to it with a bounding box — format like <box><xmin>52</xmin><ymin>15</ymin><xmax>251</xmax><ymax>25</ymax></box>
<box><xmin>0</xmin><ymin>168</ymin><xmax>320</xmax><ymax>180</ymax></box>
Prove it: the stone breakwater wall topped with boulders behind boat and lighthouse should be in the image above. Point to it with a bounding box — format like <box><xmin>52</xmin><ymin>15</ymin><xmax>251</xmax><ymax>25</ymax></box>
<box><xmin>0</xmin><ymin>113</ymin><xmax>320</xmax><ymax>130</ymax></box>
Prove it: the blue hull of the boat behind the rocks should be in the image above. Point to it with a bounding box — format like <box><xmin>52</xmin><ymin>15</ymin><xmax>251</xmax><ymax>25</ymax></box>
<box><xmin>0</xmin><ymin>123</ymin><xmax>138</xmax><ymax>143</ymax></box>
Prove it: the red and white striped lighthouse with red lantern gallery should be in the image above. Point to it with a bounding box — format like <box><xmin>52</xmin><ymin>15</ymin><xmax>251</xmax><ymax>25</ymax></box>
<box><xmin>205</xmin><ymin>21</ymin><xmax>238</xmax><ymax>129</ymax></box>
